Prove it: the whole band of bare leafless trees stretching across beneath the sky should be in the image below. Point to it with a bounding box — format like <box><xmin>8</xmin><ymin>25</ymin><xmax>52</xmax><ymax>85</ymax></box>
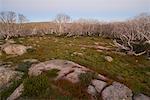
<box><xmin>0</xmin><ymin>11</ymin><xmax>150</xmax><ymax>55</ymax></box>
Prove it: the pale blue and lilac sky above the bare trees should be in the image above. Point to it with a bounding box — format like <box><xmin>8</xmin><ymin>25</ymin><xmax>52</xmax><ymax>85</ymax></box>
<box><xmin>0</xmin><ymin>0</ymin><xmax>150</xmax><ymax>21</ymax></box>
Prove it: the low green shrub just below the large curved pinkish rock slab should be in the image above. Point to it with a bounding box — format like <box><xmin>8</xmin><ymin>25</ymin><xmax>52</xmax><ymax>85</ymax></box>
<box><xmin>23</xmin><ymin>74</ymin><xmax>49</xmax><ymax>97</ymax></box>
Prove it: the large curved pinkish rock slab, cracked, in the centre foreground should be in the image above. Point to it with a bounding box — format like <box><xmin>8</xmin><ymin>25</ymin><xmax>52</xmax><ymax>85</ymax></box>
<box><xmin>28</xmin><ymin>60</ymin><xmax>89</xmax><ymax>83</ymax></box>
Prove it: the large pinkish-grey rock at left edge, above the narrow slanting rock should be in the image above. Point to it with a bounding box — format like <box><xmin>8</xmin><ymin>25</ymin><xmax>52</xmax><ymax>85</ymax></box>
<box><xmin>0</xmin><ymin>67</ymin><xmax>23</xmax><ymax>89</ymax></box>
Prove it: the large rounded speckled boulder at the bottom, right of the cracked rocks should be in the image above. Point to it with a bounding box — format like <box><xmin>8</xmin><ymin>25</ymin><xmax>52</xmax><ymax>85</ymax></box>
<box><xmin>102</xmin><ymin>82</ymin><xmax>133</xmax><ymax>100</ymax></box>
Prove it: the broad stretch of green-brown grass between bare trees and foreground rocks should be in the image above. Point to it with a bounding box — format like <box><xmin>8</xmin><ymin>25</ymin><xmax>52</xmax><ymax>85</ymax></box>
<box><xmin>0</xmin><ymin>35</ymin><xmax>150</xmax><ymax>96</ymax></box>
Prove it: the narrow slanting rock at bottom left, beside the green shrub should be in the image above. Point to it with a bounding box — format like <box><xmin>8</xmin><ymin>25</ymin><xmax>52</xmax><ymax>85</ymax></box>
<box><xmin>7</xmin><ymin>84</ymin><xmax>24</xmax><ymax>100</ymax></box>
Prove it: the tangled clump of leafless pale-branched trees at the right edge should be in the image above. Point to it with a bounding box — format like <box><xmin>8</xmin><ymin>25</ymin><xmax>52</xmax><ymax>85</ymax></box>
<box><xmin>113</xmin><ymin>14</ymin><xmax>150</xmax><ymax>56</ymax></box>
